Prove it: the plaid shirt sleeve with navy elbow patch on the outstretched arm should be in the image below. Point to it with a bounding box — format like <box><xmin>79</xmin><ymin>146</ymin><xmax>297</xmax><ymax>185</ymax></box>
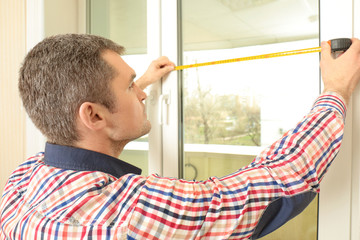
<box><xmin>128</xmin><ymin>92</ymin><xmax>346</xmax><ymax>239</ymax></box>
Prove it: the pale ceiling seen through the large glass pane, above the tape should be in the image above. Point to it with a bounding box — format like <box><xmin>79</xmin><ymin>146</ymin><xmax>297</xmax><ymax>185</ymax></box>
<box><xmin>182</xmin><ymin>0</ymin><xmax>319</xmax><ymax>50</ymax></box>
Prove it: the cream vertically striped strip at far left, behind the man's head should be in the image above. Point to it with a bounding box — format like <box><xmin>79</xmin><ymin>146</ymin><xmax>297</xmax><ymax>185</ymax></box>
<box><xmin>0</xmin><ymin>0</ymin><xmax>26</xmax><ymax>192</ymax></box>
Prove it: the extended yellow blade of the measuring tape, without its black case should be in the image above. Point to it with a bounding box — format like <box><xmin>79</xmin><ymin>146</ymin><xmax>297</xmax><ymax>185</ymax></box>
<box><xmin>175</xmin><ymin>47</ymin><xmax>321</xmax><ymax>70</ymax></box>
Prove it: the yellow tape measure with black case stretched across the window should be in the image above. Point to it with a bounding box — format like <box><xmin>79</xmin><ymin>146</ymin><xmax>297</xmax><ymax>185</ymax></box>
<box><xmin>175</xmin><ymin>38</ymin><xmax>351</xmax><ymax>70</ymax></box>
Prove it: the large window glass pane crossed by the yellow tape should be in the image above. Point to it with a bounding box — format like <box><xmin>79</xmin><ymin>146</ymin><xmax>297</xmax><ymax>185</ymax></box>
<box><xmin>182</xmin><ymin>0</ymin><xmax>319</xmax><ymax>240</ymax></box>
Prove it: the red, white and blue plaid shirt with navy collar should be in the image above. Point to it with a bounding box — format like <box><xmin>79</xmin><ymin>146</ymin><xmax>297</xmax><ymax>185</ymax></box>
<box><xmin>0</xmin><ymin>93</ymin><xmax>346</xmax><ymax>239</ymax></box>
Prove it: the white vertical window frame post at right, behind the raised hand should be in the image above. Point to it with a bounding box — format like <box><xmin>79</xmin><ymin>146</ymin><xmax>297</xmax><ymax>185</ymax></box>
<box><xmin>318</xmin><ymin>0</ymin><xmax>353</xmax><ymax>240</ymax></box>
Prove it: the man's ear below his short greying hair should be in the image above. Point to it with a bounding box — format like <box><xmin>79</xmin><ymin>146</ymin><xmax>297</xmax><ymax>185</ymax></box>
<box><xmin>79</xmin><ymin>102</ymin><xmax>106</xmax><ymax>130</ymax></box>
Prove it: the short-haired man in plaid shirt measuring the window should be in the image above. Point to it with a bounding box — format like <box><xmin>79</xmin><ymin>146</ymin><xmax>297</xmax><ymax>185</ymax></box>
<box><xmin>0</xmin><ymin>34</ymin><xmax>360</xmax><ymax>239</ymax></box>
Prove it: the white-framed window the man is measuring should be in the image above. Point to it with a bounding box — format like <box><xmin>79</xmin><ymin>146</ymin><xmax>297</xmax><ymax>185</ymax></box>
<box><xmin>88</xmin><ymin>0</ymin><xmax>359</xmax><ymax>240</ymax></box>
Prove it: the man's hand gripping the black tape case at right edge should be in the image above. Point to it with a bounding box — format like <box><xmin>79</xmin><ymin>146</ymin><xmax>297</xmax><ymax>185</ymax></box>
<box><xmin>320</xmin><ymin>38</ymin><xmax>360</xmax><ymax>104</ymax></box>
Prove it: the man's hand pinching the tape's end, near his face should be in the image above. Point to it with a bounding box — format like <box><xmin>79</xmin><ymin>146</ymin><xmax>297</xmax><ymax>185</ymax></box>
<box><xmin>136</xmin><ymin>57</ymin><xmax>175</xmax><ymax>89</ymax></box>
